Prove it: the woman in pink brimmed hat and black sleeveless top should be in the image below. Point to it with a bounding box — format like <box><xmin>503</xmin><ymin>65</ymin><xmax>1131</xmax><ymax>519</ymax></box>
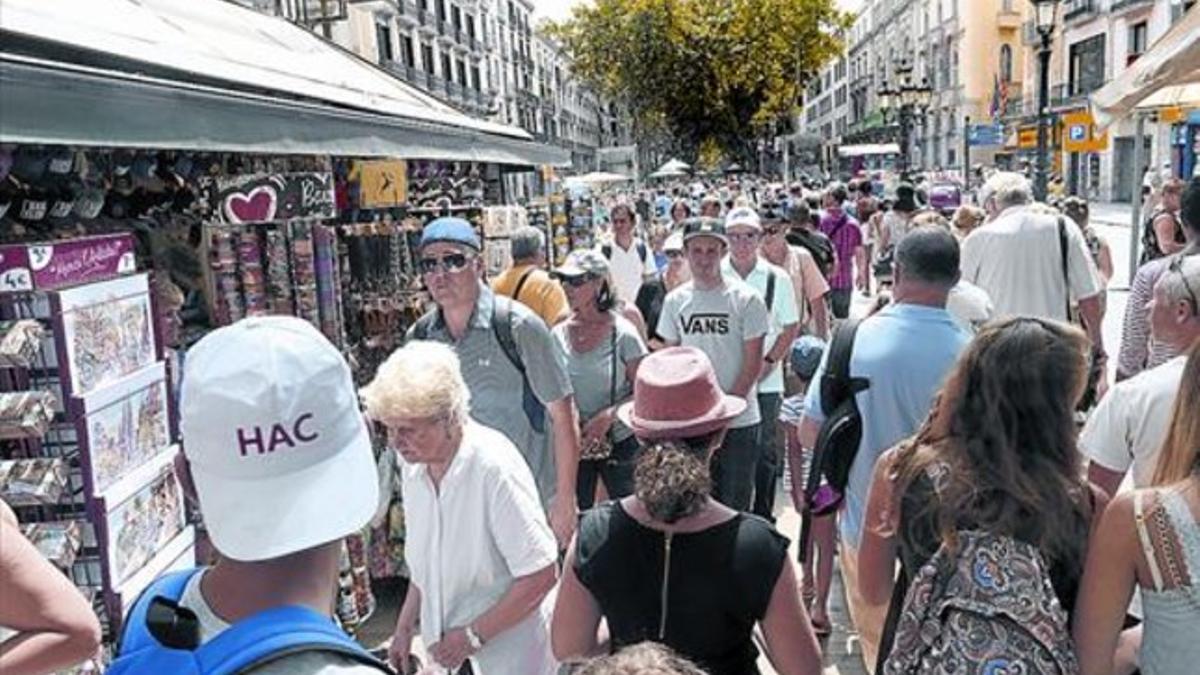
<box><xmin>551</xmin><ymin>347</ymin><xmax>821</xmax><ymax>675</ymax></box>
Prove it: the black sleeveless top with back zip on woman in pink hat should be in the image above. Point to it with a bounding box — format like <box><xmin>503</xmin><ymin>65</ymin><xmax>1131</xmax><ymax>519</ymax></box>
<box><xmin>575</xmin><ymin>501</ymin><xmax>787</xmax><ymax>675</ymax></box>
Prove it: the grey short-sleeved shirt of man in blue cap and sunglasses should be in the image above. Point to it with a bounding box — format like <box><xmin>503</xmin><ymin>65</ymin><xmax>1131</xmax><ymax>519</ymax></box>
<box><xmin>408</xmin><ymin>283</ymin><xmax>571</xmax><ymax>504</ymax></box>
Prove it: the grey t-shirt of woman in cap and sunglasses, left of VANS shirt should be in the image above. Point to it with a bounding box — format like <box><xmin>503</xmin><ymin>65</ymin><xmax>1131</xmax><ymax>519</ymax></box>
<box><xmin>553</xmin><ymin>315</ymin><xmax>646</xmax><ymax>441</ymax></box>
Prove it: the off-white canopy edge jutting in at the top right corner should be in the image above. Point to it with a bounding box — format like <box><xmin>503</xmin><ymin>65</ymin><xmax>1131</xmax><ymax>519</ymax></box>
<box><xmin>1091</xmin><ymin>8</ymin><xmax>1200</xmax><ymax>129</ymax></box>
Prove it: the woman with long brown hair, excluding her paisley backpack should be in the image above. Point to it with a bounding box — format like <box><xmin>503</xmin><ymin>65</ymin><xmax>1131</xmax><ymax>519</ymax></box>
<box><xmin>859</xmin><ymin>318</ymin><xmax>1104</xmax><ymax>669</ymax></box>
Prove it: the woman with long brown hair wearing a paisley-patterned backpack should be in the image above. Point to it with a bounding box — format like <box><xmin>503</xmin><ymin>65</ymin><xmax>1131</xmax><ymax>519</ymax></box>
<box><xmin>857</xmin><ymin>317</ymin><xmax>1105</xmax><ymax>675</ymax></box>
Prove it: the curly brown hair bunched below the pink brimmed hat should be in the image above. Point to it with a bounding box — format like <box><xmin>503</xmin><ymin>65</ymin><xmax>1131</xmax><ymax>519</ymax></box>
<box><xmin>634</xmin><ymin>430</ymin><xmax>725</xmax><ymax>522</ymax></box>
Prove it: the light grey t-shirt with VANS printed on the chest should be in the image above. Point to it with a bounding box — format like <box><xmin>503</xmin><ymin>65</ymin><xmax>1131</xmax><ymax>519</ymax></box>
<box><xmin>659</xmin><ymin>277</ymin><xmax>769</xmax><ymax>429</ymax></box>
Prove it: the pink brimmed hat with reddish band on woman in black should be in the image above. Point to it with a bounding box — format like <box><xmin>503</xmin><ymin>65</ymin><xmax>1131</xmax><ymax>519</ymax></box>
<box><xmin>617</xmin><ymin>347</ymin><xmax>746</xmax><ymax>441</ymax></box>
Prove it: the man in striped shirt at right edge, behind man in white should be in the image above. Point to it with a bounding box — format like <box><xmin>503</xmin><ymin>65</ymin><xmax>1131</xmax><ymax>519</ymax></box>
<box><xmin>1117</xmin><ymin>178</ymin><xmax>1200</xmax><ymax>382</ymax></box>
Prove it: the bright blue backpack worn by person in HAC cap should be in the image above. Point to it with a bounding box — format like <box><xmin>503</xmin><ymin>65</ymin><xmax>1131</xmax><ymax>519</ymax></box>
<box><xmin>107</xmin><ymin>568</ymin><xmax>391</xmax><ymax>675</ymax></box>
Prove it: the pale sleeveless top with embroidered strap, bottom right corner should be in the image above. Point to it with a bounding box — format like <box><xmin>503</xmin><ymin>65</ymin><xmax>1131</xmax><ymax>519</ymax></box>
<box><xmin>1134</xmin><ymin>490</ymin><xmax>1200</xmax><ymax>675</ymax></box>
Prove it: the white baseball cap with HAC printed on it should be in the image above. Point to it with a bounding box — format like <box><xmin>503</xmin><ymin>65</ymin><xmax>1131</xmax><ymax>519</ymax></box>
<box><xmin>180</xmin><ymin>316</ymin><xmax>379</xmax><ymax>561</ymax></box>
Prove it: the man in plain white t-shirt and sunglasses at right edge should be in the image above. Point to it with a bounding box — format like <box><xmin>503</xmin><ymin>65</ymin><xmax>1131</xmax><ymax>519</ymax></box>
<box><xmin>1079</xmin><ymin>256</ymin><xmax>1200</xmax><ymax>495</ymax></box>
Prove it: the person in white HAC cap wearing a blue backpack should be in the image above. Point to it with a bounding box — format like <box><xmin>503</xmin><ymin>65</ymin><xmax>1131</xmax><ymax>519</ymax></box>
<box><xmin>108</xmin><ymin>316</ymin><xmax>390</xmax><ymax>675</ymax></box>
